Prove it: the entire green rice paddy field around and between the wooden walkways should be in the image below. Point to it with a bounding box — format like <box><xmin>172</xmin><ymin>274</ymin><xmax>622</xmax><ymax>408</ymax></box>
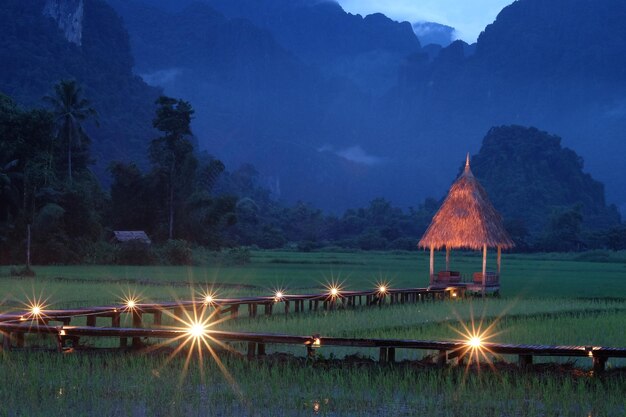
<box><xmin>0</xmin><ymin>251</ymin><xmax>626</xmax><ymax>417</ymax></box>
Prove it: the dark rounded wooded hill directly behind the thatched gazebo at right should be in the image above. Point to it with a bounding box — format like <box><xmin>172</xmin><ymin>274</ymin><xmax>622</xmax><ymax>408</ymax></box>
<box><xmin>471</xmin><ymin>126</ymin><xmax>620</xmax><ymax>234</ymax></box>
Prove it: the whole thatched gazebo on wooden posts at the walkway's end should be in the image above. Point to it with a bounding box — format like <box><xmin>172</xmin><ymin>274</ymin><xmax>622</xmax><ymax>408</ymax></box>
<box><xmin>419</xmin><ymin>154</ymin><xmax>515</xmax><ymax>294</ymax></box>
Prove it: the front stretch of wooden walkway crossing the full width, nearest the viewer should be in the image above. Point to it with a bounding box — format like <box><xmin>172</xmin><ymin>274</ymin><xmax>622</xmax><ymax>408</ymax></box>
<box><xmin>0</xmin><ymin>323</ymin><xmax>626</xmax><ymax>373</ymax></box>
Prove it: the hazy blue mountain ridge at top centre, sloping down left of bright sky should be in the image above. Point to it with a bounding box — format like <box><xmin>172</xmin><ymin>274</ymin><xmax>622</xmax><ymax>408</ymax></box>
<box><xmin>206</xmin><ymin>0</ymin><xmax>420</xmax><ymax>96</ymax></box>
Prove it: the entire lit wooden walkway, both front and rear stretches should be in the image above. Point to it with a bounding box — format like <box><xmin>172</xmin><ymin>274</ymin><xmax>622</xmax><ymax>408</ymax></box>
<box><xmin>0</xmin><ymin>286</ymin><xmax>626</xmax><ymax>372</ymax></box>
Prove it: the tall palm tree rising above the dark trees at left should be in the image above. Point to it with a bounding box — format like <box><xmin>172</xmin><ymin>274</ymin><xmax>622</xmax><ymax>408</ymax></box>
<box><xmin>44</xmin><ymin>80</ymin><xmax>98</xmax><ymax>183</ymax></box>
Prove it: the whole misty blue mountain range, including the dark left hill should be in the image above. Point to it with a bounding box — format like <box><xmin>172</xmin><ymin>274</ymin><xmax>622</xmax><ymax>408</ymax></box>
<box><xmin>0</xmin><ymin>0</ymin><xmax>626</xmax><ymax>221</ymax></box>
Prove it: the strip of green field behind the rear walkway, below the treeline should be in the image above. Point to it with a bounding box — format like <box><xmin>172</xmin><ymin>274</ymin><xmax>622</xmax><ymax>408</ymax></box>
<box><xmin>0</xmin><ymin>251</ymin><xmax>626</xmax><ymax>307</ymax></box>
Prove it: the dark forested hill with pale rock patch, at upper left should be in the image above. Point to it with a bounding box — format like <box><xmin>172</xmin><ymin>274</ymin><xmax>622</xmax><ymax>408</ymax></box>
<box><xmin>0</xmin><ymin>0</ymin><xmax>159</xmax><ymax>178</ymax></box>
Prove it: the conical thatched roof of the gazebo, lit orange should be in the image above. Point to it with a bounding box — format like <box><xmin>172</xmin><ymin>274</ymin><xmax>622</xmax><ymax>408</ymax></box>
<box><xmin>419</xmin><ymin>154</ymin><xmax>515</xmax><ymax>250</ymax></box>
